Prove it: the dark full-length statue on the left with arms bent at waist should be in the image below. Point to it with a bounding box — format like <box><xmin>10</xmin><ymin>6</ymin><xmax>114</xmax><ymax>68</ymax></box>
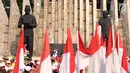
<box><xmin>18</xmin><ymin>5</ymin><xmax>37</xmax><ymax>59</ymax></box>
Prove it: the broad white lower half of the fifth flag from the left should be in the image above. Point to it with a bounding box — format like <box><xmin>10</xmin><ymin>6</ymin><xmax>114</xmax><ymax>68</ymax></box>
<box><xmin>88</xmin><ymin>46</ymin><xmax>106</xmax><ymax>73</ymax></box>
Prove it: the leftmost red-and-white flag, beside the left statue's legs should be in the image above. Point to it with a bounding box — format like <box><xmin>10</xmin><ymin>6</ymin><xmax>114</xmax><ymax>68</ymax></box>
<box><xmin>14</xmin><ymin>29</ymin><xmax>24</xmax><ymax>73</ymax></box>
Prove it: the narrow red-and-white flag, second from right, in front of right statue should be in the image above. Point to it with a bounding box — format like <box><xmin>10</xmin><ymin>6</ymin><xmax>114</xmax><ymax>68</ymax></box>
<box><xmin>106</xmin><ymin>25</ymin><xmax>120</xmax><ymax>73</ymax></box>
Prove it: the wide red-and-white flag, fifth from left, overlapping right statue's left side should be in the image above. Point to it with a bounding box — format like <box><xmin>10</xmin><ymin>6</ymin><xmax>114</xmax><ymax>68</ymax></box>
<box><xmin>88</xmin><ymin>25</ymin><xmax>106</xmax><ymax>73</ymax></box>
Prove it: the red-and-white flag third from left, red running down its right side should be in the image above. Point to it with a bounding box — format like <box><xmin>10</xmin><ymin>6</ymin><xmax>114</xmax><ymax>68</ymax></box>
<box><xmin>59</xmin><ymin>29</ymin><xmax>76</xmax><ymax>73</ymax></box>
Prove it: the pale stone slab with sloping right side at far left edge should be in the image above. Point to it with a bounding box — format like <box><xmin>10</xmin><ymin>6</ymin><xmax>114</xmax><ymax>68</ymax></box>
<box><xmin>0</xmin><ymin>0</ymin><xmax>9</xmax><ymax>55</ymax></box>
